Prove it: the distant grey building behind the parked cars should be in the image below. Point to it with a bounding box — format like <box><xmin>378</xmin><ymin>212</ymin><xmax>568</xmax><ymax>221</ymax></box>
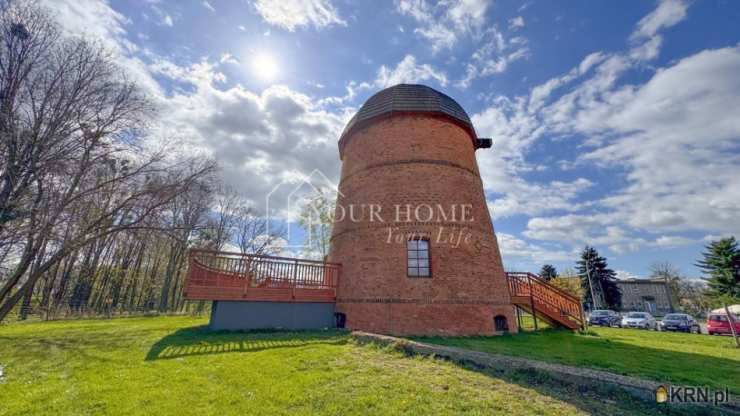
<box><xmin>617</xmin><ymin>278</ymin><xmax>673</xmax><ymax>315</ymax></box>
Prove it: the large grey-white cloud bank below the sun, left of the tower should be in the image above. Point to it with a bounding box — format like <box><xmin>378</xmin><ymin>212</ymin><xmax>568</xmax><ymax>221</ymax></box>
<box><xmin>43</xmin><ymin>0</ymin><xmax>351</xmax><ymax>218</ymax></box>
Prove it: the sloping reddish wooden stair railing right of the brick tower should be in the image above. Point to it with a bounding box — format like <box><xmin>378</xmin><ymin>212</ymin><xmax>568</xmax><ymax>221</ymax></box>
<box><xmin>506</xmin><ymin>272</ymin><xmax>584</xmax><ymax>327</ymax></box>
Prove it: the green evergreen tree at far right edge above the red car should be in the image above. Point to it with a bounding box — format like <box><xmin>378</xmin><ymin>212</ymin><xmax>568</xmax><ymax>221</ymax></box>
<box><xmin>696</xmin><ymin>237</ymin><xmax>740</xmax><ymax>299</ymax></box>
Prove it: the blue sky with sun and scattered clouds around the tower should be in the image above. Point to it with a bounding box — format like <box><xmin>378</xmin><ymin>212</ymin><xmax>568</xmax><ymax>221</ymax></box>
<box><xmin>46</xmin><ymin>0</ymin><xmax>740</xmax><ymax>277</ymax></box>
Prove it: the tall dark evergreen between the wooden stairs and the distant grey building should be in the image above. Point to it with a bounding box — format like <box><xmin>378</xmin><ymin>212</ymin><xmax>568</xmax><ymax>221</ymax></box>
<box><xmin>576</xmin><ymin>246</ymin><xmax>622</xmax><ymax>310</ymax></box>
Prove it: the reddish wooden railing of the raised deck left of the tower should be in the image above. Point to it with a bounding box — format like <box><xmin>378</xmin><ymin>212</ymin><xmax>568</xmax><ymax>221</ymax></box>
<box><xmin>185</xmin><ymin>250</ymin><xmax>342</xmax><ymax>302</ymax></box>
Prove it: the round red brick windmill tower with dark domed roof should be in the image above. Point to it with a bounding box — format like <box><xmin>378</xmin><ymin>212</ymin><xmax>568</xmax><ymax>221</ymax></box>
<box><xmin>329</xmin><ymin>84</ymin><xmax>517</xmax><ymax>335</ymax></box>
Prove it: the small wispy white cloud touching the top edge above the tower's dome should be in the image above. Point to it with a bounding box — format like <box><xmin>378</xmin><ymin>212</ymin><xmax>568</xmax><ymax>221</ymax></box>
<box><xmin>396</xmin><ymin>0</ymin><xmax>489</xmax><ymax>52</ymax></box>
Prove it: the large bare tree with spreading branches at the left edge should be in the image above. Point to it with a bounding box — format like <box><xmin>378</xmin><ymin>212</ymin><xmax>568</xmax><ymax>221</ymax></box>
<box><xmin>0</xmin><ymin>2</ymin><xmax>220</xmax><ymax>320</ymax></box>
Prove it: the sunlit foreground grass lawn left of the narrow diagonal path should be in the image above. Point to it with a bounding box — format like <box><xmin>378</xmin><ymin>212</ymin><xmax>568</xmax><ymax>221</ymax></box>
<box><xmin>0</xmin><ymin>317</ymin><xmax>704</xmax><ymax>416</ymax></box>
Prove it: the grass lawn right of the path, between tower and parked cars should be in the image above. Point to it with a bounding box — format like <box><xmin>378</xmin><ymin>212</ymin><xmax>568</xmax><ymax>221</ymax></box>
<box><xmin>416</xmin><ymin>327</ymin><xmax>740</xmax><ymax>394</ymax></box>
